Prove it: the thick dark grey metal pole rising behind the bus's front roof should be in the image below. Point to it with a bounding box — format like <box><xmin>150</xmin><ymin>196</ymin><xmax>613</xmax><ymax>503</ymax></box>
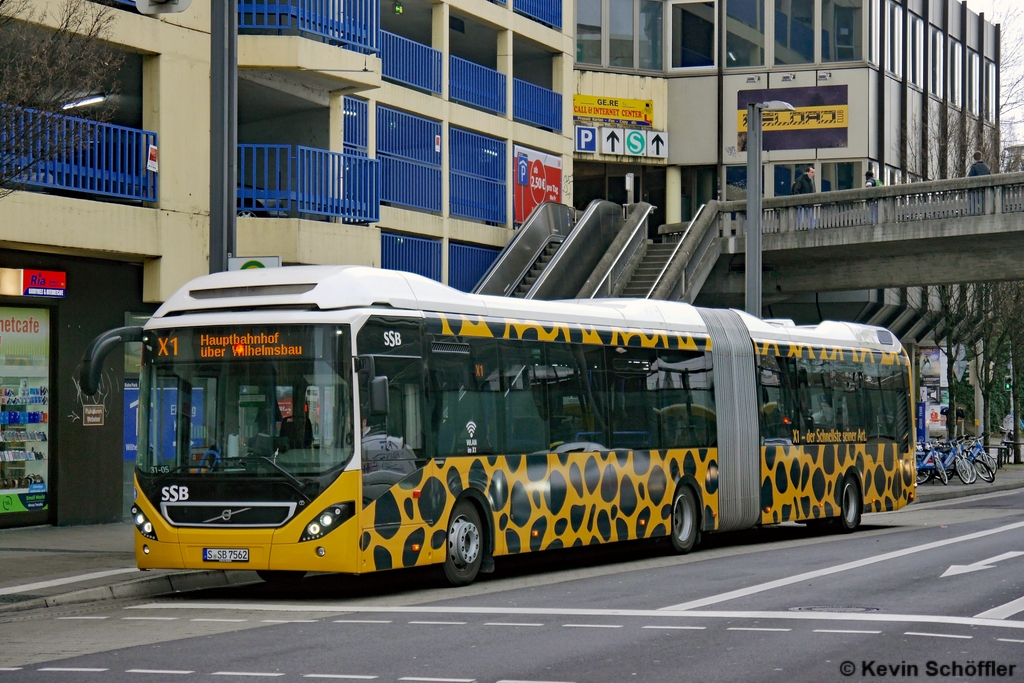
<box><xmin>210</xmin><ymin>0</ymin><xmax>239</xmax><ymax>272</ymax></box>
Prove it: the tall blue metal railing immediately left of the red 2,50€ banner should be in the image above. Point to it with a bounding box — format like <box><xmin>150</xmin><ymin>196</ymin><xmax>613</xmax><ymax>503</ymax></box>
<box><xmin>449</xmin><ymin>127</ymin><xmax>508</xmax><ymax>224</ymax></box>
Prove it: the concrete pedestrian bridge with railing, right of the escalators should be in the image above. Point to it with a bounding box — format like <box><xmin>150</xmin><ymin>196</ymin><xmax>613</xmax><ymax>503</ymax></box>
<box><xmin>650</xmin><ymin>173</ymin><xmax>1024</xmax><ymax>307</ymax></box>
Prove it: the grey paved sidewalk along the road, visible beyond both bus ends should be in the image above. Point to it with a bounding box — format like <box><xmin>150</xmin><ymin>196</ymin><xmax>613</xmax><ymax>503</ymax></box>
<box><xmin>0</xmin><ymin>465</ymin><xmax>1024</xmax><ymax>613</ymax></box>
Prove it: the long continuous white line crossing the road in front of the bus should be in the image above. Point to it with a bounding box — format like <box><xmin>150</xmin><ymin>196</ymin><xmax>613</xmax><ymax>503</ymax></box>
<box><xmin>125</xmin><ymin>602</ymin><xmax>1024</xmax><ymax>629</ymax></box>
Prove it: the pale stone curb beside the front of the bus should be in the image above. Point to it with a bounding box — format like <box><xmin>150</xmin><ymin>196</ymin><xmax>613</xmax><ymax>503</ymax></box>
<box><xmin>0</xmin><ymin>569</ymin><xmax>259</xmax><ymax>614</ymax></box>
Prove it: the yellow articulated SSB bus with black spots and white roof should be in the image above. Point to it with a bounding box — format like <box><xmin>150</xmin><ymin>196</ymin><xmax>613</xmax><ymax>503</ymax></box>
<box><xmin>86</xmin><ymin>266</ymin><xmax>915</xmax><ymax>585</ymax></box>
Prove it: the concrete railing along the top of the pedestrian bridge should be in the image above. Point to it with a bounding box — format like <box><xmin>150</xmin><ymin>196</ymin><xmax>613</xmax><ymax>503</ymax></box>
<box><xmin>712</xmin><ymin>173</ymin><xmax>1024</xmax><ymax>237</ymax></box>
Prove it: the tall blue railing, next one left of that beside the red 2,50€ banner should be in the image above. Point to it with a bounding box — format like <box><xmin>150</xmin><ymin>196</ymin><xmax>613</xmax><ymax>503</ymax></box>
<box><xmin>377</xmin><ymin>105</ymin><xmax>441</xmax><ymax>213</ymax></box>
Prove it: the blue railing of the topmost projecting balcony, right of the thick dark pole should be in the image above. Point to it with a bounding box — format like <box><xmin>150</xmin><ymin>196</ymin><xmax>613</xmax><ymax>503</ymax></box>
<box><xmin>239</xmin><ymin>0</ymin><xmax>380</xmax><ymax>52</ymax></box>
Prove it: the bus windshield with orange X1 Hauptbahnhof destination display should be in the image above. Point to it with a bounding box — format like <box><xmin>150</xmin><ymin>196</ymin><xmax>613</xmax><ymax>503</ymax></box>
<box><xmin>138</xmin><ymin>325</ymin><xmax>353</xmax><ymax>485</ymax></box>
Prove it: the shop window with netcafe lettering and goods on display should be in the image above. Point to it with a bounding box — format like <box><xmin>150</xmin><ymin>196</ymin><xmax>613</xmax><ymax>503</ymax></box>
<box><xmin>0</xmin><ymin>307</ymin><xmax>50</xmax><ymax>514</ymax></box>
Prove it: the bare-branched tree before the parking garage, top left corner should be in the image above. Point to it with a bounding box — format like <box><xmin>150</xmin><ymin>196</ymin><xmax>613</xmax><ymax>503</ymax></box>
<box><xmin>0</xmin><ymin>0</ymin><xmax>123</xmax><ymax>198</ymax></box>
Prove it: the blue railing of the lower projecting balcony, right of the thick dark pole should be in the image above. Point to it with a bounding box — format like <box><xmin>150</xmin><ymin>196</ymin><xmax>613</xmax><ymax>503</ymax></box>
<box><xmin>238</xmin><ymin>144</ymin><xmax>380</xmax><ymax>223</ymax></box>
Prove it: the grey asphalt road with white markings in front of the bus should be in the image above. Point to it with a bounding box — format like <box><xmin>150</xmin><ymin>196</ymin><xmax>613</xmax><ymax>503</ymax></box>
<box><xmin>6</xmin><ymin>492</ymin><xmax>1024</xmax><ymax>683</ymax></box>
